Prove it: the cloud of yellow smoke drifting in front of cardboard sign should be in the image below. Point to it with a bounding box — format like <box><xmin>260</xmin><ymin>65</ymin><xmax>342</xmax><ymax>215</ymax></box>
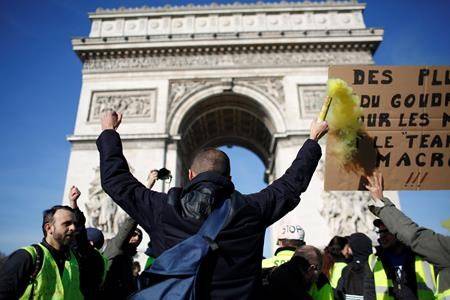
<box><xmin>327</xmin><ymin>78</ymin><xmax>363</xmax><ymax>166</ymax></box>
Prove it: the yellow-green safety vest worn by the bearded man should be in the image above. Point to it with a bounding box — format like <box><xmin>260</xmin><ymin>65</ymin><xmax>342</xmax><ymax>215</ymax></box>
<box><xmin>20</xmin><ymin>244</ymin><xmax>83</xmax><ymax>300</ymax></box>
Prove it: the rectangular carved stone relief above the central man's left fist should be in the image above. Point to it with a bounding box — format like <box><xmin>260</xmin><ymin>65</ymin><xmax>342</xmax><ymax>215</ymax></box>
<box><xmin>88</xmin><ymin>89</ymin><xmax>156</xmax><ymax>122</ymax></box>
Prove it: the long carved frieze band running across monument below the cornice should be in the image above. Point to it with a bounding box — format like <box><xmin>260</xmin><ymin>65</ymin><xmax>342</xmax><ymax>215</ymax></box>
<box><xmin>83</xmin><ymin>50</ymin><xmax>372</xmax><ymax>73</ymax></box>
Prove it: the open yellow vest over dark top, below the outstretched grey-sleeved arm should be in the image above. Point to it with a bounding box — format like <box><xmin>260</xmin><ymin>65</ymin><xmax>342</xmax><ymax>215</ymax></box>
<box><xmin>368</xmin><ymin>254</ymin><xmax>436</xmax><ymax>300</ymax></box>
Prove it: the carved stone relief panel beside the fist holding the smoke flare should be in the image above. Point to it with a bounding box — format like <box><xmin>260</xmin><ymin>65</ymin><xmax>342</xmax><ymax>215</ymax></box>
<box><xmin>298</xmin><ymin>85</ymin><xmax>326</xmax><ymax>118</ymax></box>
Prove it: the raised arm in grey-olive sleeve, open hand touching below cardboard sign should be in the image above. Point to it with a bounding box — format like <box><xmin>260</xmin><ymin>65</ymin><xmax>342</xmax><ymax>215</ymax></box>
<box><xmin>366</xmin><ymin>173</ymin><xmax>450</xmax><ymax>268</ymax></box>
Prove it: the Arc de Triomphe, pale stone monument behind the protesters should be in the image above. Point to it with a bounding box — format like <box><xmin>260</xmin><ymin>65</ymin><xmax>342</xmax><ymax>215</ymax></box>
<box><xmin>64</xmin><ymin>1</ymin><xmax>398</xmax><ymax>256</ymax></box>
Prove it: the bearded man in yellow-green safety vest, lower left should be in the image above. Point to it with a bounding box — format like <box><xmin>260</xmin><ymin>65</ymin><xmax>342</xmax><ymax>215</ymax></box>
<box><xmin>0</xmin><ymin>205</ymin><xmax>83</xmax><ymax>299</ymax></box>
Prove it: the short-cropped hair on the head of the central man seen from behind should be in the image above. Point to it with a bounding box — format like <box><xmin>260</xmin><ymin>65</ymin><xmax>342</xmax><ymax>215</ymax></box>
<box><xmin>191</xmin><ymin>147</ymin><xmax>230</xmax><ymax>177</ymax></box>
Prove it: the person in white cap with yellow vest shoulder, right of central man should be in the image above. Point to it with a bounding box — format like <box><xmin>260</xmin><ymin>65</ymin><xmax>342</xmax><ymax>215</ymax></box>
<box><xmin>262</xmin><ymin>224</ymin><xmax>305</xmax><ymax>269</ymax></box>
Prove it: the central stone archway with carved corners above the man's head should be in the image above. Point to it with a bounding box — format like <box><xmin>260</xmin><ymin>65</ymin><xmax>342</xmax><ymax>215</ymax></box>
<box><xmin>169</xmin><ymin>78</ymin><xmax>285</xmax><ymax>183</ymax></box>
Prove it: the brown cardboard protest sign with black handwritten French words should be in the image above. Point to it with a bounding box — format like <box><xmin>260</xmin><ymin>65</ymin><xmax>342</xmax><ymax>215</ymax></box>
<box><xmin>325</xmin><ymin>65</ymin><xmax>450</xmax><ymax>190</ymax></box>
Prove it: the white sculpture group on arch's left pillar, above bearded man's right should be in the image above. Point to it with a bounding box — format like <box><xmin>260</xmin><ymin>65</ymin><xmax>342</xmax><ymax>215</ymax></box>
<box><xmin>85</xmin><ymin>167</ymin><xmax>132</xmax><ymax>239</ymax></box>
